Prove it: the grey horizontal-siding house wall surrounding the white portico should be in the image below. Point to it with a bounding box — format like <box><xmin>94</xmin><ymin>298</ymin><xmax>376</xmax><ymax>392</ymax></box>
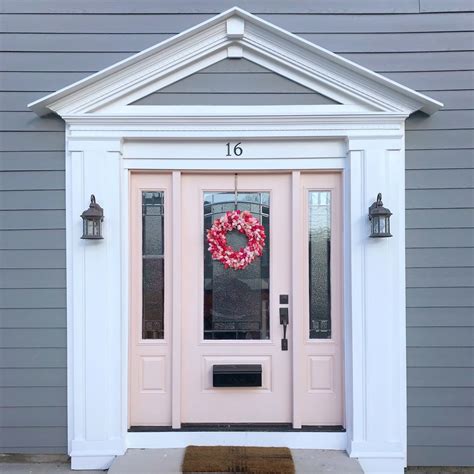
<box><xmin>0</xmin><ymin>0</ymin><xmax>474</xmax><ymax>465</ymax></box>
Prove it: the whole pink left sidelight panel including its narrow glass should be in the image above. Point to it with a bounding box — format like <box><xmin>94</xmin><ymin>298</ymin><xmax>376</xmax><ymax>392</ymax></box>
<box><xmin>129</xmin><ymin>173</ymin><xmax>172</xmax><ymax>426</ymax></box>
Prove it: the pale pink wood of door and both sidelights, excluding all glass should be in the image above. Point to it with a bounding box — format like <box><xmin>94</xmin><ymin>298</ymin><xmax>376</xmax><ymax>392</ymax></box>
<box><xmin>129</xmin><ymin>172</ymin><xmax>344</xmax><ymax>428</ymax></box>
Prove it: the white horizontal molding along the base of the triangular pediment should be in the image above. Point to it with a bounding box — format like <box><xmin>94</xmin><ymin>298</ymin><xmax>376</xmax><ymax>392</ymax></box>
<box><xmin>63</xmin><ymin>111</ymin><xmax>406</xmax><ymax>136</ymax></box>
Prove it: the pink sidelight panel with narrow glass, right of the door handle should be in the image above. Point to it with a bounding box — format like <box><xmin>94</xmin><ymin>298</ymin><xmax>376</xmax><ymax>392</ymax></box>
<box><xmin>300</xmin><ymin>173</ymin><xmax>344</xmax><ymax>425</ymax></box>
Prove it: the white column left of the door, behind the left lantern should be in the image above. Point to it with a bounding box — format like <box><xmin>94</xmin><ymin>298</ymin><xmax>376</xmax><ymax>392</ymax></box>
<box><xmin>66</xmin><ymin>140</ymin><xmax>126</xmax><ymax>469</ymax></box>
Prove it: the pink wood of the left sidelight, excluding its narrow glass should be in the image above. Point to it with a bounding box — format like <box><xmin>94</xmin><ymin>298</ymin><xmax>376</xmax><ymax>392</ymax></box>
<box><xmin>129</xmin><ymin>173</ymin><xmax>173</xmax><ymax>426</ymax></box>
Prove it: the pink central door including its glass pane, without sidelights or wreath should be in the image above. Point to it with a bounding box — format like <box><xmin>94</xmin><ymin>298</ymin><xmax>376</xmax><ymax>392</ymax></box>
<box><xmin>182</xmin><ymin>174</ymin><xmax>291</xmax><ymax>423</ymax></box>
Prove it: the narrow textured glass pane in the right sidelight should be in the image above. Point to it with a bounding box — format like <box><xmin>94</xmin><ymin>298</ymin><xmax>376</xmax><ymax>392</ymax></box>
<box><xmin>309</xmin><ymin>191</ymin><xmax>331</xmax><ymax>339</ymax></box>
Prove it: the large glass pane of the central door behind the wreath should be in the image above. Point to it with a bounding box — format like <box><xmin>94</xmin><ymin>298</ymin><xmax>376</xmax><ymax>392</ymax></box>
<box><xmin>204</xmin><ymin>192</ymin><xmax>270</xmax><ymax>339</ymax></box>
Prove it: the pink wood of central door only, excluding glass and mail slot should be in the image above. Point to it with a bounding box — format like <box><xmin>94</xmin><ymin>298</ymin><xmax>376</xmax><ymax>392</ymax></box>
<box><xmin>182</xmin><ymin>174</ymin><xmax>291</xmax><ymax>423</ymax></box>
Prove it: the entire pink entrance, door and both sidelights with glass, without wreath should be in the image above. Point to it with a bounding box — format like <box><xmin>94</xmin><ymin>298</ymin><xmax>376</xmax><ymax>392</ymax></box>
<box><xmin>129</xmin><ymin>172</ymin><xmax>344</xmax><ymax>427</ymax></box>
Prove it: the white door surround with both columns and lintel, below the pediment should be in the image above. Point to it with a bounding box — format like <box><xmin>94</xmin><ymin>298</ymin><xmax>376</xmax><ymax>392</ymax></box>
<box><xmin>66</xmin><ymin>115</ymin><xmax>406</xmax><ymax>472</ymax></box>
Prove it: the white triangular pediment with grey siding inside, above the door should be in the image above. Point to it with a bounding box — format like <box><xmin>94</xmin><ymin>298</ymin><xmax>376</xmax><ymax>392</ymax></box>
<box><xmin>29</xmin><ymin>8</ymin><xmax>442</xmax><ymax>117</ymax></box>
